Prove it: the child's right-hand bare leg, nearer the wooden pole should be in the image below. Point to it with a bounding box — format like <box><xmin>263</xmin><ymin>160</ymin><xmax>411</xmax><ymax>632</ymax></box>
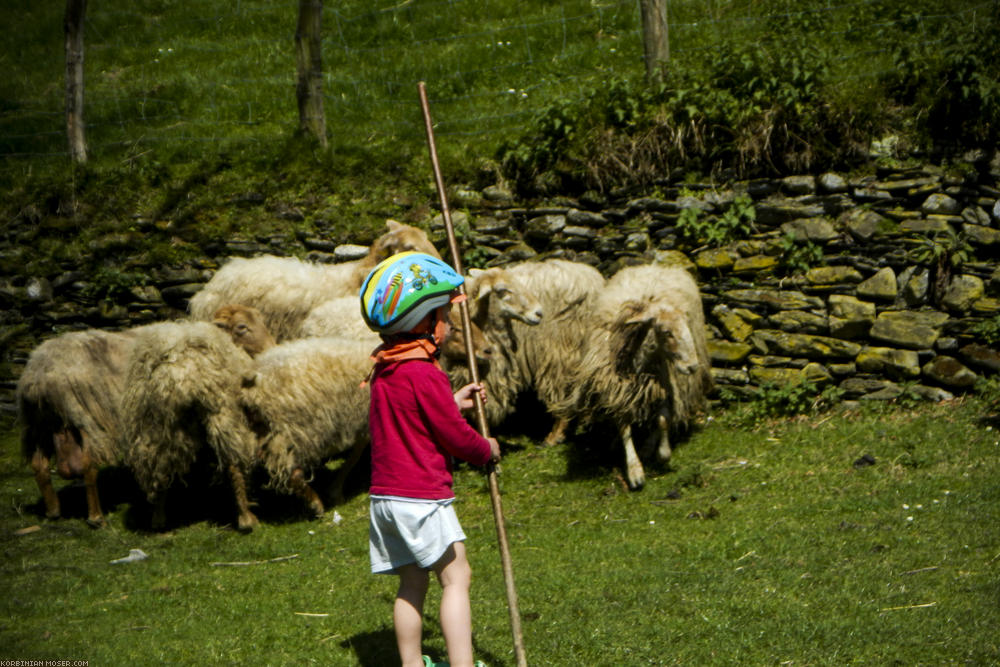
<box><xmin>434</xmin><ymin>542</ymin><xmax>472</xmax><ymax>667</ymax></box>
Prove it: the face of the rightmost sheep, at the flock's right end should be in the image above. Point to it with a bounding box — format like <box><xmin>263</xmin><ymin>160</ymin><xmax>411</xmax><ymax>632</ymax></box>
<box><xmin>612</xmin><ymin>299</ymin><xmax>698</xmax><ymax>375</ymax></box>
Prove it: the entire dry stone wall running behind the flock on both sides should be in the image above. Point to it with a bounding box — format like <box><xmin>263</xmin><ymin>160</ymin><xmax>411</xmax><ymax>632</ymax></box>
<box><xmin>0</xmin><ymin>158</ymin><xmax>1000</xmax><ymax>412</ymax></box>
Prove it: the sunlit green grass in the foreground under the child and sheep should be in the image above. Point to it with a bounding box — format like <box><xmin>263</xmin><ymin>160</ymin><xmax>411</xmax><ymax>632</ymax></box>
<box><xmin>0</xmin><ymin>398</ymin><xmax>1000</xmax><ymax>665</ymax></box>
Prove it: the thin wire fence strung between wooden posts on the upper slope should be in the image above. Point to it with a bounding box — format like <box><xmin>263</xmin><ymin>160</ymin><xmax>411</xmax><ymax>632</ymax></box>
<box><xmin>0</xmin><ymin>0</ymin><xmax>997</xmax><ymax>162</ymax></box>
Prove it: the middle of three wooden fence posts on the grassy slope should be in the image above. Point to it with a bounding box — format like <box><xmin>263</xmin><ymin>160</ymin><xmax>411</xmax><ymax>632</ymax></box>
<box><xmin>295</xmin><ymin>0</ymin><xmax>327</xmax><ymax>148</ymax></box>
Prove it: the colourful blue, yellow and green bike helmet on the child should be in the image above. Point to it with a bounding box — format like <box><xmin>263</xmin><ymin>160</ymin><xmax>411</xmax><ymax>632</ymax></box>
<box><xmin>360</xmin><ymin>252</ymin><xmax>465</xmax><ymax>335</ymax></box>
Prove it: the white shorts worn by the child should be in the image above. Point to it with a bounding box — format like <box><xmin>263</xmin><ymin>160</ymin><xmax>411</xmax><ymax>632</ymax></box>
<box><xmin>368</xmin><ymin>496</ymin><xmax>465</xmax><ymax>574</ymax></box>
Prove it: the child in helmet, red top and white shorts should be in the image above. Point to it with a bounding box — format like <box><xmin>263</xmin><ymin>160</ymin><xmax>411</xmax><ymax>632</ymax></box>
<box><xmin>361</xmin><ymin>252</ymin><xmax>500</xmax><ymax>667</ymax></box>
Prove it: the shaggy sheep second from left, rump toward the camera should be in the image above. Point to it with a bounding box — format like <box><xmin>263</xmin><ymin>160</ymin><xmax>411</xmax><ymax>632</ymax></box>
<box><xmin>120</xmin><ymin>321</ymin><xmax>266</xmax><ymax>532</ymax></box>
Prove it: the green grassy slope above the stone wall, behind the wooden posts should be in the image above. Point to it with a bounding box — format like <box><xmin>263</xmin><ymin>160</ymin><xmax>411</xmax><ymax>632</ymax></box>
<box><xmin>0</xmin><ymin>0</ymin><xmax>1000</xmax><ymax>194</ymax></box>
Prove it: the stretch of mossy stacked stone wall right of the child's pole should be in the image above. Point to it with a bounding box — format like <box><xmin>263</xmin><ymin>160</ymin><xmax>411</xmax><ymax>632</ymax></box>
<box><xmin>462</xmin><ymin>160</ymin><xmax>1000</xmax><ymax>400</ymax></box>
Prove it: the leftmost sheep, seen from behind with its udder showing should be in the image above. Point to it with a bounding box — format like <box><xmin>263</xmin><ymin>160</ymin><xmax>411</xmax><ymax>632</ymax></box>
<box><xmin>16</xmin><ymin>329</ymin><xmax>141</xmax><ymax>528</ymax></box>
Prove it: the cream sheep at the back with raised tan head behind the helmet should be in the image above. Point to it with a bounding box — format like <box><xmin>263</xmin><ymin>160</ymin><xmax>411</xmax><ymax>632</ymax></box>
<box><xmin>188</xmin><ymin>220</ymin><xmax>440</xmax><ymax>342</ymax></box>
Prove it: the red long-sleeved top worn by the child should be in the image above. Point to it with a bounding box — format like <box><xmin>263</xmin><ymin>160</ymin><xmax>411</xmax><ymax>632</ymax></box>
<box><xmin>369</xmin><ymin>360</ymin><xmax>490</xmax><ymax>500</ymax></box>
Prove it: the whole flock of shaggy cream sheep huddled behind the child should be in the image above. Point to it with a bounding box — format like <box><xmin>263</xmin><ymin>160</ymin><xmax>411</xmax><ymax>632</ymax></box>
<box><xmin>17</xmin><ymin>221</ymin><xmax>711</xmax><ymax>531</ymax></box>
